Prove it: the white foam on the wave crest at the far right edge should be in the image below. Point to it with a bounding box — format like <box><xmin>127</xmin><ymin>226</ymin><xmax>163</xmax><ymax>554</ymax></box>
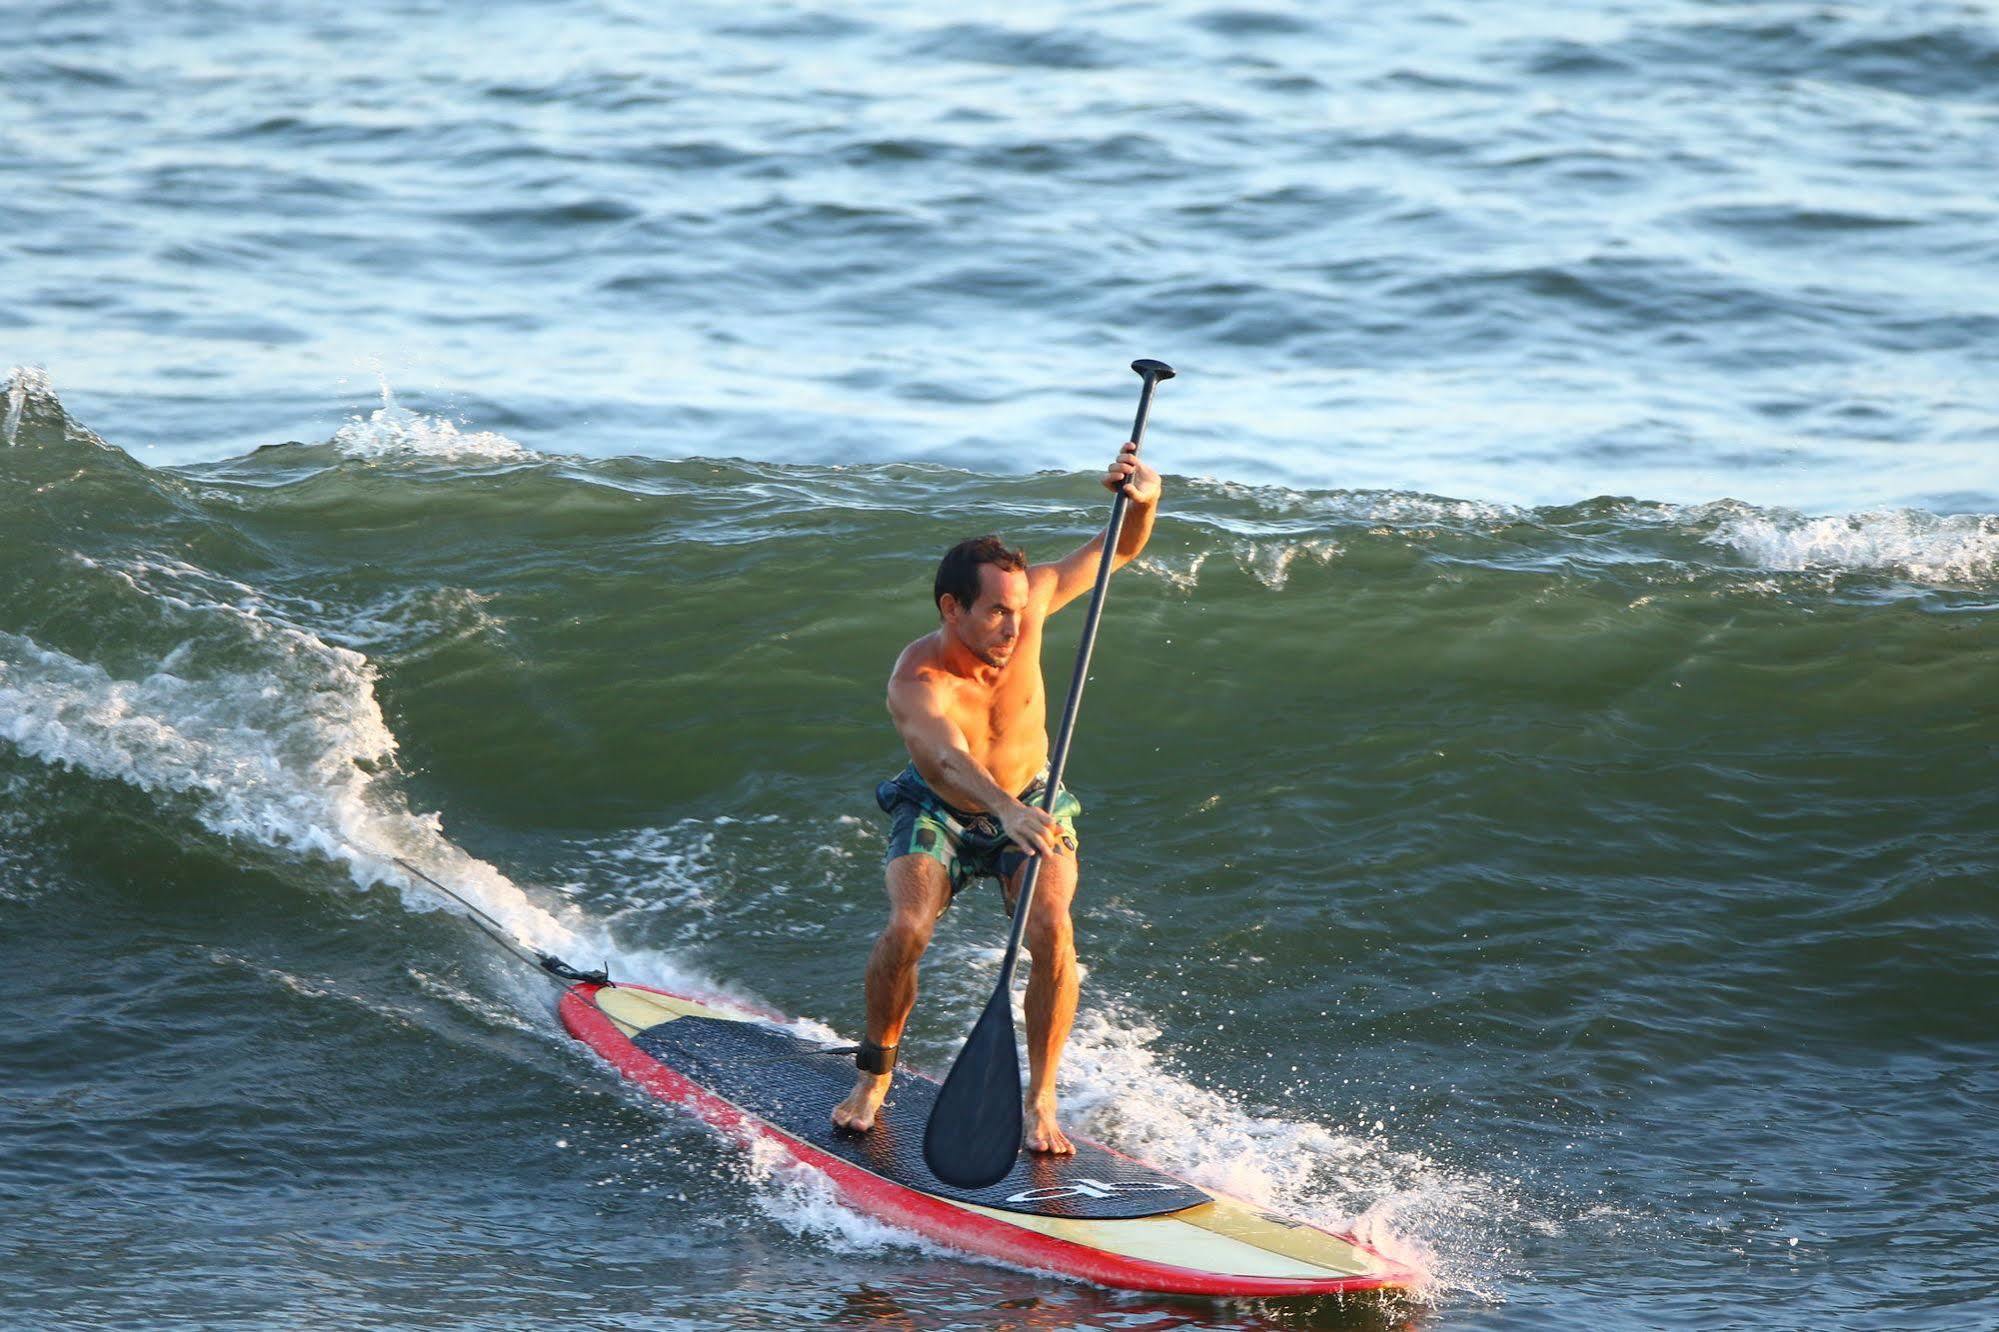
<box><xmin>1693</xmin><ymin>502</ymin><xmax>1999</xmax><ymax>584</ymax></box>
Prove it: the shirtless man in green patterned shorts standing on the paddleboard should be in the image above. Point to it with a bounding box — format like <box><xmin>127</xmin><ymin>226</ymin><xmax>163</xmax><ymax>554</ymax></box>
<box><xmin>834</xmin><ymin>444</ymin><xmax>1159</xmax><ymax>1154</ymax></box>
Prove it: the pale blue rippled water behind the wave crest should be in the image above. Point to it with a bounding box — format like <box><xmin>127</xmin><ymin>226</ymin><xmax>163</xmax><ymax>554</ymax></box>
<box><xmin>15</xmin><ymin>2</ymin><xmax>1999</xmax><ymax>510</ymax></box>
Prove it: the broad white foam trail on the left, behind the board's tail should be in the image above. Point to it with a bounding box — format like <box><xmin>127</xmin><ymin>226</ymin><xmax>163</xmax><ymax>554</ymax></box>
<box><xmin>0</xmin><ymin>560</ymin><xmax>712</xmax><ymax>988</ymax></box>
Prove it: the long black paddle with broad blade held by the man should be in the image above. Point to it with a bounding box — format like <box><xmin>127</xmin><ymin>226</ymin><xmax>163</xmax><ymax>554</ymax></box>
<box><xmin>924</xmin><ymin>360</ymin><xmax>1173</xmax><ymax>1188</ymax></box>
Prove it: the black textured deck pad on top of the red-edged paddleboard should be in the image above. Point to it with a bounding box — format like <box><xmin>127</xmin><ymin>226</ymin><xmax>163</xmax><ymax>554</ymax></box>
<box><xmin>632</xmin><ymin>1018</ymin><xmax>1207</xmax><ymax>1220</ymax></box>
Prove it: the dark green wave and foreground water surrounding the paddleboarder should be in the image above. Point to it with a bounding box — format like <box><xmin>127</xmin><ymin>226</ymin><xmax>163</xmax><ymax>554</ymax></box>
<box><xmin>0</xmin><ymin>374</ymin><xmax>1999</xmax><ymax>1326</ymax></box>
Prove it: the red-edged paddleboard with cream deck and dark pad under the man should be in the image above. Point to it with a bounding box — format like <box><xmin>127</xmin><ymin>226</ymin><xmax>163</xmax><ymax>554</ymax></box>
<box><xmin>560</xmin><ymin>980</ymin><xmax>1417</xmax><ymax>1296</ymax></box>
